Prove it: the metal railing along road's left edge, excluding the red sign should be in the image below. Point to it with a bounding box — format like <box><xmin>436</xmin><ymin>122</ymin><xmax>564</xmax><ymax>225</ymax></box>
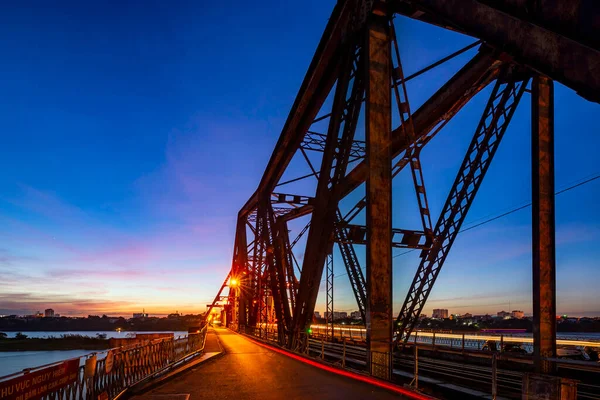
<box><xmin>0</xmin><ymin>325</ymin><xmax>208</xmax><ymax>400</ymax></box>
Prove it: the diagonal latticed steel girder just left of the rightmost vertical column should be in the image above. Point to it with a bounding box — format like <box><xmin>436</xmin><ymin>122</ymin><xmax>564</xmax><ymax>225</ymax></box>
<box><xmin>396</xmin><ymin>70</ymin><xmax>527</xmax><ymax>343</ymax></box>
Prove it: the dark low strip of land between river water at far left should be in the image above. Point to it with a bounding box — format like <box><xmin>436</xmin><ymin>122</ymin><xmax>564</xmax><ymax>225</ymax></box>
<box><xmin>0</xmin><ymin>336</ymin><xmax>109</xmax><ymax>352</ymax></box>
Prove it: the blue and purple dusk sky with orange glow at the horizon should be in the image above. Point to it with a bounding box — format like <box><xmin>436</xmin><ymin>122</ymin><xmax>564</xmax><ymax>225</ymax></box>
<box><xmin>0</xmin><ymin>0</ymin><xmax>600</xmax><ymax>315</ymax></box>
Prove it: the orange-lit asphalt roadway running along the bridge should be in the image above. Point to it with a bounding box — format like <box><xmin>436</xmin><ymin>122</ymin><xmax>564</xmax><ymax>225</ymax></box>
<box><xmin>137</xmin><ymin>329</ymin><xmax>402</xmax><ymax>400</ymax></box>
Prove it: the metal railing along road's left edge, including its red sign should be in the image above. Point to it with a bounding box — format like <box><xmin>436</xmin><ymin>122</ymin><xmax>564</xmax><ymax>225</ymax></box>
<box><xmin>0</xmin><ymin>325</ymin><xmax>208</xmax><ymax>400</ymax></box>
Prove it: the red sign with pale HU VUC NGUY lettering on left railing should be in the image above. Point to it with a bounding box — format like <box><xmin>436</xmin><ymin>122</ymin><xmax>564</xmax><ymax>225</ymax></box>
<box><xmin>0</xmin><ymin>358</ymin><xmax>79</xmax><ymax>400</ymax></box>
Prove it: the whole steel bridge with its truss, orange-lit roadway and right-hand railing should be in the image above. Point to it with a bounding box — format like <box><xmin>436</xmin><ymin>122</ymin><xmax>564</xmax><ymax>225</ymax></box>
<box><xmin>1</xmin><ymin>0</ymin><xmax>600</xmax><ymax>399</ymax></box>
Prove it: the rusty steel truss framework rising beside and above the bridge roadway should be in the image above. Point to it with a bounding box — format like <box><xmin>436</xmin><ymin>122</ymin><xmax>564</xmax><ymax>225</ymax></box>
<box><xmin>207</xmin><ymin>0</ymin><xmax>600</xmax><ymax>390</ymax></box>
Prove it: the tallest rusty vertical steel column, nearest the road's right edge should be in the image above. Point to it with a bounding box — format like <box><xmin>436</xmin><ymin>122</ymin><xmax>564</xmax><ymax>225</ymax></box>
<box><xmin>366</xmin><ymin>3</ymin><xmax>392</xmax><ymax>380</ymax></box>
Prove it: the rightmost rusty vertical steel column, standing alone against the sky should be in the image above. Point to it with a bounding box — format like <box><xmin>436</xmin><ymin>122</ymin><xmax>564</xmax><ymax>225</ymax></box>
<box><xmin>531</xmin><ymin>75</ymin><xmax>556</xmax><ymax>374</ymax></box>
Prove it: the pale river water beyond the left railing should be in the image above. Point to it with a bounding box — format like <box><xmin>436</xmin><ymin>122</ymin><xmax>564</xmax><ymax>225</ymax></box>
<box><xmin>0</xmin><ymin>331</ymin><xmax>187</xmax><ymax>377</ymax></box>
